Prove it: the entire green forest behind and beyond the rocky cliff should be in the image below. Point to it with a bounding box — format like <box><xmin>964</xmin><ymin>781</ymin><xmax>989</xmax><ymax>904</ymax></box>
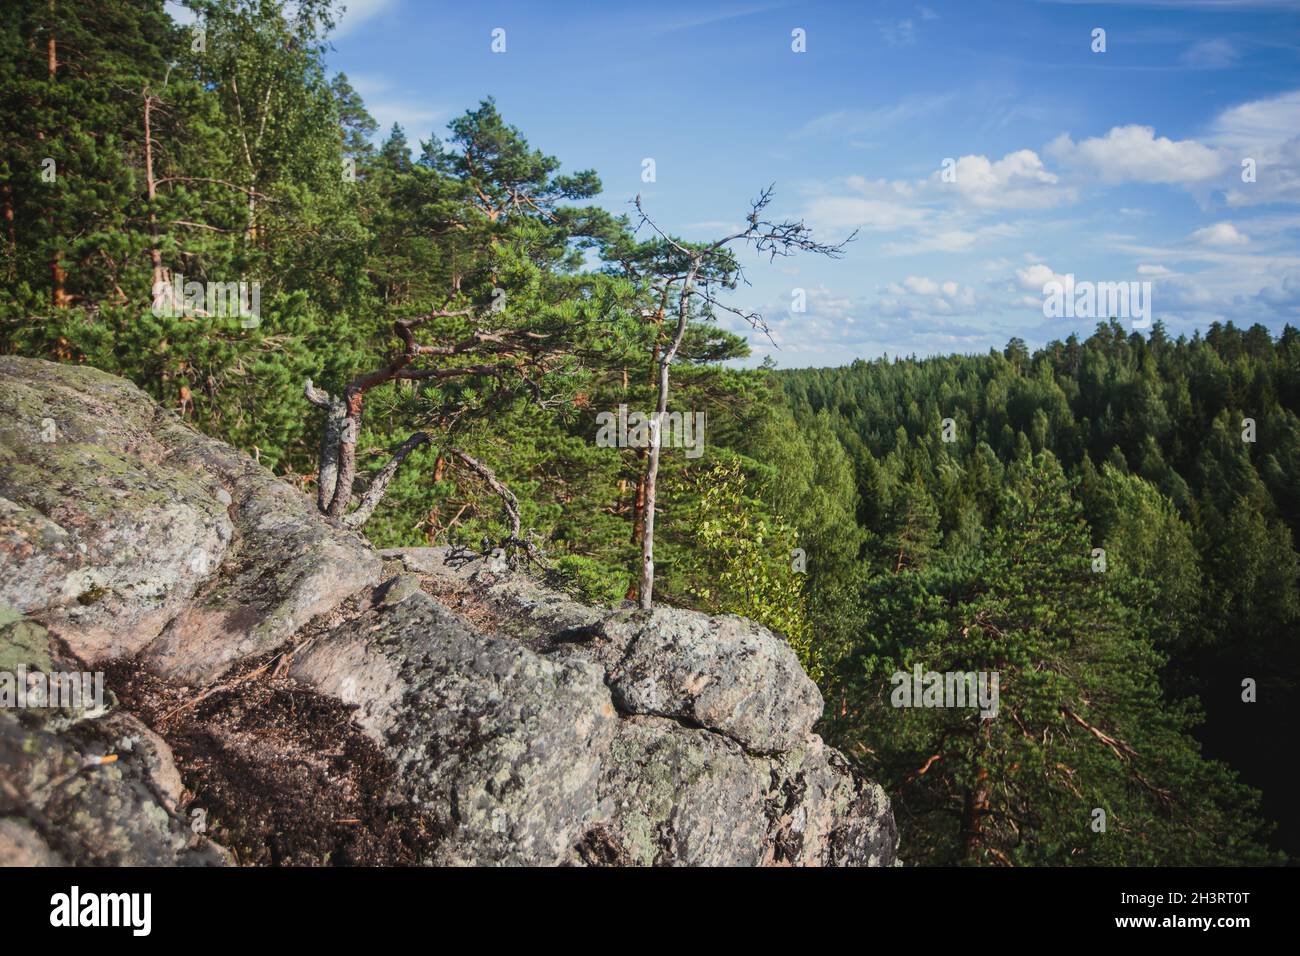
<box><xmin>0</xmin><ymin>0</ymin><xmax>1300</xmax><ymax>865</ymax></box>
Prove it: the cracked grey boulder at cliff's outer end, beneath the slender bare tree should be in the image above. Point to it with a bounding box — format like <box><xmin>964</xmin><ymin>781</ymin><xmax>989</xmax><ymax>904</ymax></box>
<box><xmin>382</xmin><ymin>548</ymin><xmax>898</xmax><ymax>866</ymax></box>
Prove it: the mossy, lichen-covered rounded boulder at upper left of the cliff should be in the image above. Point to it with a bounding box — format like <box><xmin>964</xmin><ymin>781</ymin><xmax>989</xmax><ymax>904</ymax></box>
<box><xmin>0</xmin><ymin>355</ymin><xmax>381</xmax><ymax>683</ymax></box>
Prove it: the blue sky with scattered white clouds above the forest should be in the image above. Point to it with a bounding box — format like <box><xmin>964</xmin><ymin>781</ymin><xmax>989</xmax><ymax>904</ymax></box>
<box><xmin>239</xmin><ymin>0</ymin><xmax>1300</xmax><ymax>367</ymax></box>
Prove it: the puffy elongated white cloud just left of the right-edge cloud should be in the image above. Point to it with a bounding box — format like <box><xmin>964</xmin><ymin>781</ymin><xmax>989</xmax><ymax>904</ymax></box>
<box><xmin>1047</xmin><ymin>125</ymin><xmax>1230</xmax><ymax>183</ymax></box>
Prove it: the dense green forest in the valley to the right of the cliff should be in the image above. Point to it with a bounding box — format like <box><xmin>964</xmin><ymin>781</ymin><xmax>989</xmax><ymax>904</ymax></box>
<box><xmin>777</xmin><ymin>323</ymin><xmax>1300</xmax><ymax>864</ymax></box>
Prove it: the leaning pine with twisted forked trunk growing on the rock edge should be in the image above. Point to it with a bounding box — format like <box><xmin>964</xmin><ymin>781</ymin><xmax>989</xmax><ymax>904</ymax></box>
<box><xmin>304</xmin><ymin>235</ymin><xmax>627</xmax><ymax>562</ymax></box>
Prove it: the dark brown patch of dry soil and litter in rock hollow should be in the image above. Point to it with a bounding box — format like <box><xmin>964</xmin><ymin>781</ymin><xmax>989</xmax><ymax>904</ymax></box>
<box><xmin>105</xmin><ymin>656</ymin><xmax>438</xmax><ymax>866</ymax></box>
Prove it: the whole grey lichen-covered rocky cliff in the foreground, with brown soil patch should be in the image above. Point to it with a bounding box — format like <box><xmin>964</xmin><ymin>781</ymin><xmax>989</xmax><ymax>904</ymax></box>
<box><xmin>0</xmin><ymin>356</ymin><xmax>897</xmax><ymax>866</ymax></box>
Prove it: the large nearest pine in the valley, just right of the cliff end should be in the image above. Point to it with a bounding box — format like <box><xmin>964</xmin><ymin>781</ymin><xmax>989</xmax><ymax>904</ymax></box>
<box><xmin>837</xmin><ymin>454</ymin><xmax>1270</xmax><ymax>865</ymax></box>
